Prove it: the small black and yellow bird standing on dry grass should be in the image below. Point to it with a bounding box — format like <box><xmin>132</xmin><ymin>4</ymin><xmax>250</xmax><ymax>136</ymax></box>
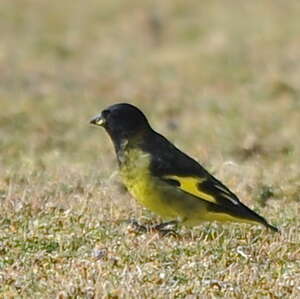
<box><xmin>90</xmin><ymin>103</ymin><xmax>278</xmax><ymax>232</ymax></box>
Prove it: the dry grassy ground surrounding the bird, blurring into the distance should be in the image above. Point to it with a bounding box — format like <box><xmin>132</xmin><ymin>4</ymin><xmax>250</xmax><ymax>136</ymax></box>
<box><xmin>0</xmin><ymin>0</ymin><xmax>300</xmax><ymax>298</ymax></box>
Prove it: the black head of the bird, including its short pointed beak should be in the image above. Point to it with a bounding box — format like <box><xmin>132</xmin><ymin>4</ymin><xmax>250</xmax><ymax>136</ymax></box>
<box><xmin>90</xmin><ymin>103</ymin><xmax>150</xmax><ymax>143</ymax></box>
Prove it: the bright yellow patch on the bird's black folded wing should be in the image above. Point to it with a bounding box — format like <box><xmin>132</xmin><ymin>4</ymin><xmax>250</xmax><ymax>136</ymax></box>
<box><xmin>164</xmin><ymin>175</ymin><xmax>218</xmax><ymax>204</ymax></box>
